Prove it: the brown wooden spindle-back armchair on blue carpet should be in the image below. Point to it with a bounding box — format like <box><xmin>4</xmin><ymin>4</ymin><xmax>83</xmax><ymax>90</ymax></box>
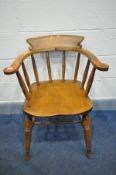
<box><xmin>4</xmin><ymin>35</ymin><xmax>109</xmax><ymax>160</ymax></box>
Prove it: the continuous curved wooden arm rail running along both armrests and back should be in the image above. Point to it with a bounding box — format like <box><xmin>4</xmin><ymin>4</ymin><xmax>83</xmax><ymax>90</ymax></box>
<box><xmin>4</xmin><ymin>47</ymin><xmax>109</xmax><ymax>74</ymax></box>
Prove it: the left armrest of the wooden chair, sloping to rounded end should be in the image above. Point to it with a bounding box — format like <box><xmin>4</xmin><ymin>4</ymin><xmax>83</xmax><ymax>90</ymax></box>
<box><xmin>3</xmin><ymin>50</ymin><xmax>32</xmax><ymax>74</ymax></box>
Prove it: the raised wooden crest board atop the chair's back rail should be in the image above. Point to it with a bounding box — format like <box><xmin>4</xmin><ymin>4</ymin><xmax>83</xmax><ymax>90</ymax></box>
<box><xmin>27</xmin><ymin>35</ymin><xmax>84</xmax><ymax>50</ymax></box>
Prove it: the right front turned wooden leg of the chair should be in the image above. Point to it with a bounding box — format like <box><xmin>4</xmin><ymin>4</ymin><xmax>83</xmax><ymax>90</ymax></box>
<box><xmin>82</xmin><ymin>115</ymin><xmax>91</xmax><ymax>158</ymax></box>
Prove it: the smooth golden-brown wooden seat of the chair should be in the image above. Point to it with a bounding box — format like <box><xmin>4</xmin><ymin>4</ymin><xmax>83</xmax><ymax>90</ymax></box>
<box><xmin>24</xmin><ymin>80</ymin><xmax>93</xmax><ymax>117</ymax></box>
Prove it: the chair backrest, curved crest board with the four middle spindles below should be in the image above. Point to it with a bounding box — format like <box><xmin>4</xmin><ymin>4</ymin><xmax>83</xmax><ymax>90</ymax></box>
<box><xmin>27</xmin><ymin>35</ymin><xmax>84</xmax><ymax>82</ymax></box>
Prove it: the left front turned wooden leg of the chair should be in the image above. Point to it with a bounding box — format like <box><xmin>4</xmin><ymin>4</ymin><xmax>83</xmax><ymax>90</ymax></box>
<box><xmin>24</xmin><ymin>120</ymin><xmax>33</xmax><ymax>160</ymax></box>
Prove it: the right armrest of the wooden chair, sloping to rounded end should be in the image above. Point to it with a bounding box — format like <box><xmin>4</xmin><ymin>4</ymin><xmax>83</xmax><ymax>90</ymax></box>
<box><xmin>77</xmin><ymin>48</ymin><xmax>109</xmax><ymax>71</ymax></box>
